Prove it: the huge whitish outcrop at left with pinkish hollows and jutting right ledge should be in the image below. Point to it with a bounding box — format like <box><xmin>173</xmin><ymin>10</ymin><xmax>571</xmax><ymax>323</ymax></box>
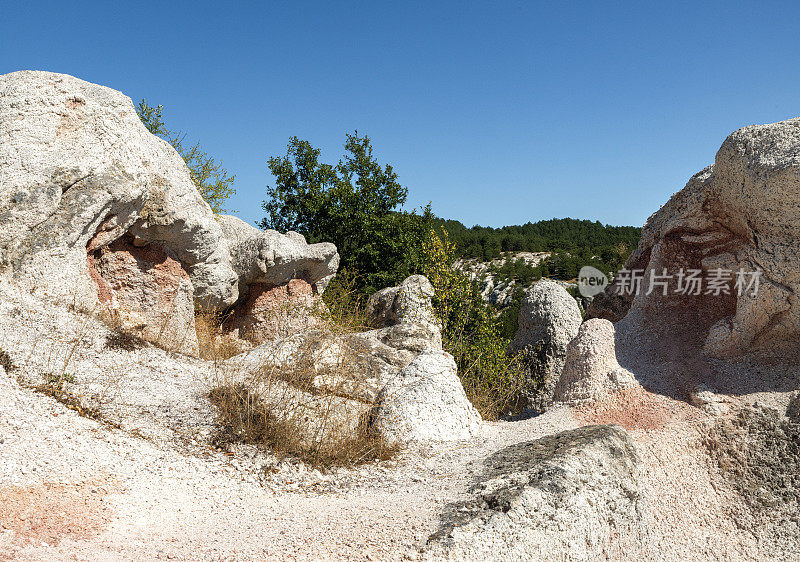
<box><xmin>0</xmin><ymin>71</ymin><xmax>339</xmax><ymax>352</ymax></box>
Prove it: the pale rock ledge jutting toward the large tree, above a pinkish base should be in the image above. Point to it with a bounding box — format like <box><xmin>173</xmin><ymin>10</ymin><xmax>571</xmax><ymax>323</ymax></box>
<box><xmin>219</xmin><ymin>215</ymin><xmax>339</xmax><ymax>294</ymax></box>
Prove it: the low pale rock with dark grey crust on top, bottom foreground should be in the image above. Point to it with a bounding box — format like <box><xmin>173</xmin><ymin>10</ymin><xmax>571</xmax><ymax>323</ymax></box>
<box><xmin>424</xmin><ymin>425</ymin><xmax>645</xmax><ymax>561</ymax></box>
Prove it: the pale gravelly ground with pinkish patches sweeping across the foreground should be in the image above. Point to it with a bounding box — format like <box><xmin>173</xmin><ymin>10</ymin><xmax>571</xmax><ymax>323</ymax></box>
<box><xmin>0</xmin><ymin>284</ymin><xmax>788</xmax><ymax>561</ymax></box>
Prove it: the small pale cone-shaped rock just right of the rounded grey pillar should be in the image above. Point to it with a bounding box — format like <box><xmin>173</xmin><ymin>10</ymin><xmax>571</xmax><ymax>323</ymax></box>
<box><xmin>553</xmin><ymin>319</ymin><xmax>637</xmax><ymax>404</ymax></box>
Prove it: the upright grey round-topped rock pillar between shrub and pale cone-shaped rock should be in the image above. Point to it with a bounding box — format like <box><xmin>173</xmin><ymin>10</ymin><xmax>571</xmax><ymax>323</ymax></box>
<box><xmin>509</xmin><ymin>279</ymin><xmax>582</xmax><ymax>410</ymax></box>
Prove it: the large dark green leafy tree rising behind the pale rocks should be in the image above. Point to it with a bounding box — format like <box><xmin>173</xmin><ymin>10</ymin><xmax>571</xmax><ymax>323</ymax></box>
<box><xmin>259</xmin><ymin>132</ymin><xmax>432</xmax><ymax>292</ymax></box>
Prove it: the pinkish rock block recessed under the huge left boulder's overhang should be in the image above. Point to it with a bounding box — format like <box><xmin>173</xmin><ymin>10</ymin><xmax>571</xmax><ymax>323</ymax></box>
<box><xmin>88</xmin><ymin>237</ymin><xmax>197</xmax><ymax>355</ymax></box>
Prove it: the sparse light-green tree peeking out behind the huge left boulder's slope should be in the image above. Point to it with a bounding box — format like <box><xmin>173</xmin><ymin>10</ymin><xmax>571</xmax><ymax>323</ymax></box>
<box><xmin>136</xmin><ymin>99</ymin><xmax>236</xmax><ymax>213</ymax></box>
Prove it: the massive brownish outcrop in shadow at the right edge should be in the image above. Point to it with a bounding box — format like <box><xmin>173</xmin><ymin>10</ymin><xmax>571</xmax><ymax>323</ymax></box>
<box><xmin>592</xmin><ymin>119</ymin><xmax>800</xmax><ymax>362</ymax></box>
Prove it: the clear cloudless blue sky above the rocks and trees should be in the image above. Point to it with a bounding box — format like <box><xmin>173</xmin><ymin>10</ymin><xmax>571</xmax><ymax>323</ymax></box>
<box><xmin>0</xmin><ymin>1</ymin><xmax>800</xmax><ymax>226</ymax></box>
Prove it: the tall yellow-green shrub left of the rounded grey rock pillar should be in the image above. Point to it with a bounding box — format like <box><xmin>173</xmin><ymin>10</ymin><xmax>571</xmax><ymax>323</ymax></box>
<box><xmin>422</xmin><ymin>226</ymin><xmax>525</xmax><ymax>419</ymax></box>
